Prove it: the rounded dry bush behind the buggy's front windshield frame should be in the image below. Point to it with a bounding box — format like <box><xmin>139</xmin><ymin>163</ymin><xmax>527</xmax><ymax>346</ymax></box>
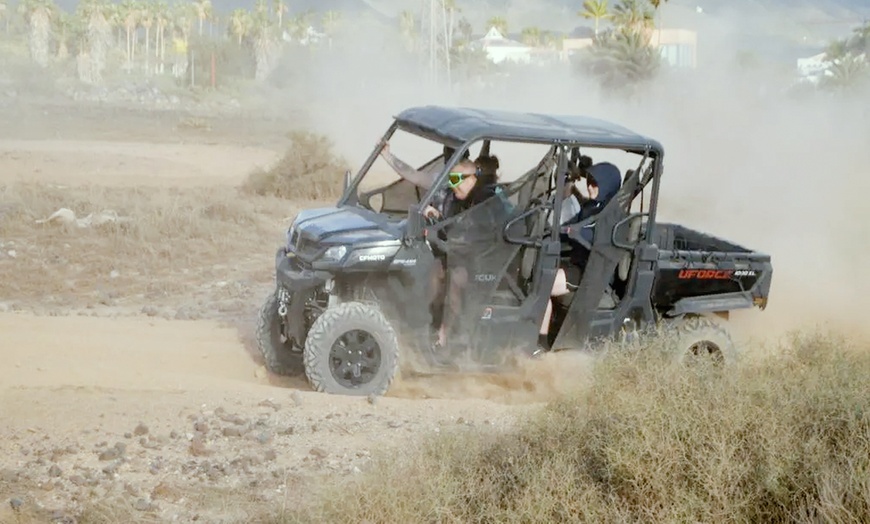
<box><xmin>242</xmin><ymin>131</ymin><xmax>348</xmax><ymax>200</ymax></box>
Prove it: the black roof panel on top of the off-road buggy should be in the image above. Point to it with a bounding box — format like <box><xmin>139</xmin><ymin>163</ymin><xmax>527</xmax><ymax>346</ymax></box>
<box><xmin>395</xmin><ymin>105</ymin><xmax>664</xmax><ymax>156</ymax></box>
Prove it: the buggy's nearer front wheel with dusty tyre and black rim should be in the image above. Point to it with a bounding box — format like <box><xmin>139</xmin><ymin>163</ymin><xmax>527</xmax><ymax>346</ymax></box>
<box><xmin>304</xmin><ymin>302</ymin><xmax>399</xmax><ymax>396</ymax></box>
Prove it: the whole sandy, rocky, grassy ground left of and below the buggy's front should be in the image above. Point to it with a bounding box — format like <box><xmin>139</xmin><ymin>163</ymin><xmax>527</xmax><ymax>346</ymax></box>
<box><xmin>0</xmin><ymin>97</ymin><xmax>564</xmax><ymax>523</ymax></box>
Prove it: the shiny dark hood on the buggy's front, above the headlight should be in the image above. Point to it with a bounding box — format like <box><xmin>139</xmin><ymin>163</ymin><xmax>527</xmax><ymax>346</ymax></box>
<box><xmin>289</xmin><ymin>206</ymin><xmax>402</xmax><ymax>244</ymax></box>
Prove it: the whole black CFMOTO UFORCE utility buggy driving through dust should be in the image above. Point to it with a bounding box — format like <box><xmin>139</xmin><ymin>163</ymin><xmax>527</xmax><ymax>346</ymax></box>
<box><xmin>258</xmin><ymin>106</ymin><xmax>772</xmax><ymax>395</ymax></box>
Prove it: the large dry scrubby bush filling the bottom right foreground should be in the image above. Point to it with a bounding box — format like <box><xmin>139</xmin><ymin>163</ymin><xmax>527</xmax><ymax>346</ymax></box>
<box><xmin>262</xmin><ymin>335</ymin><xmax>870</xmax><ymax>523</ymax></box>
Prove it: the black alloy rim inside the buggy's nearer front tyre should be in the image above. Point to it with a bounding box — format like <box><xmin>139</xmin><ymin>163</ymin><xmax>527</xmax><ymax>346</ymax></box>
<box><xmin>329</xmin><ymin>329</ymin><xmax>381</xmax><ymax>388</ymax></box>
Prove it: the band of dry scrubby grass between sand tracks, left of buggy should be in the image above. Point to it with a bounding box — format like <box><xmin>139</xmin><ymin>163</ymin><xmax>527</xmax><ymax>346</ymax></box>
<box><xmin>0</xmin><ymin>183</ymin><xmax>294</xmax><ymax>304</ymax></box>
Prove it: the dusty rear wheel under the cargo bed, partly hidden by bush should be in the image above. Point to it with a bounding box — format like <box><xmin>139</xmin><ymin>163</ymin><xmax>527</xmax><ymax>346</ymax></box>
<box><xmin>673</xmin><ymin>317</ymin><xmax>739</xmax><ymax>366</ymax></box>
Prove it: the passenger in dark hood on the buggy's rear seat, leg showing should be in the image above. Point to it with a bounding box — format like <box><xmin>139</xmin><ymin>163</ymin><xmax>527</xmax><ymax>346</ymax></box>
<box><xmin>538</xmin><ymin>162</ymin><xmax>622</xmax><ymax>350</ymax></box>
